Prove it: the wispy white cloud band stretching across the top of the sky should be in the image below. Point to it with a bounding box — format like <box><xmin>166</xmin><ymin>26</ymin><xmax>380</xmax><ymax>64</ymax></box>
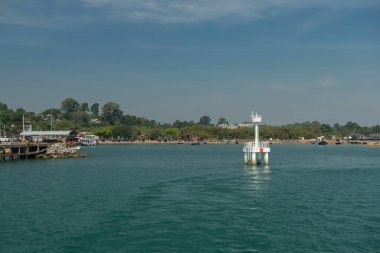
<box><xmin>0</xmin><ymin>0</ymin><xmax>379</xmax><ymax>26</ymax></box>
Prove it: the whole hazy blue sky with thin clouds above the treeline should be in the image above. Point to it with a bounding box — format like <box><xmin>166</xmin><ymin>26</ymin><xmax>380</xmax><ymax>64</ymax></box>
<box><xmin>0</xmin><ymin>0</ymin><xmax>380</xmax><ymax>126</ymax></box>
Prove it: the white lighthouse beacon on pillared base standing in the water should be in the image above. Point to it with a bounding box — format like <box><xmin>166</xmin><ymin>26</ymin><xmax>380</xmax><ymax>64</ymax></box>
<box><xmin>243</xmin><ymin>112</ymin><xmax>270</xmax><ymax>165</ymax></box>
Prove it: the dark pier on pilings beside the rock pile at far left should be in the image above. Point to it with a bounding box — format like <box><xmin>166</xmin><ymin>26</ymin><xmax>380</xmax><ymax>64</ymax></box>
<box><xmin>0</xmin><ymin>143</ymin><xmax>51</xmax><ymax>161</ymax></box>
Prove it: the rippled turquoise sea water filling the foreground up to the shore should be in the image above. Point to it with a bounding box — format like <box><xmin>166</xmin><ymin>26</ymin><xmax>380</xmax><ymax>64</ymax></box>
<box><xmin>0</xmin><ymin>145</ymin><xmax>380</xmax><ymax>252</ymax></box>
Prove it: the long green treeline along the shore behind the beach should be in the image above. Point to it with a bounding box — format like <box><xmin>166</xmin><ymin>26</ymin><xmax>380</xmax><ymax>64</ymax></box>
<box><xmin>0</xmin><ymin>98</ymin><xmax>380</xmax><ymax>140</ymax></box>
